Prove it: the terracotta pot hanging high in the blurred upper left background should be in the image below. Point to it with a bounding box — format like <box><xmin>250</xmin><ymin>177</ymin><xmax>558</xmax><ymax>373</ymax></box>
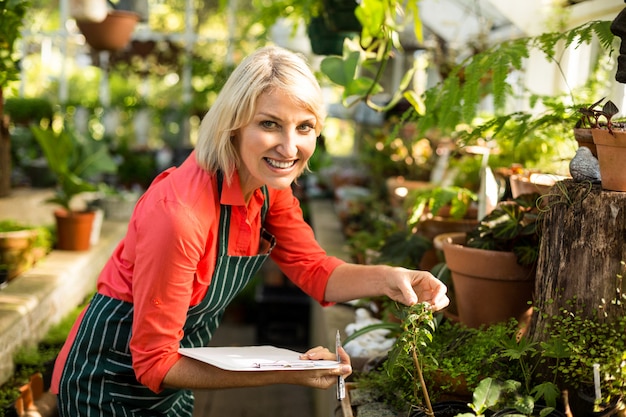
<box><xmin>76</xmin><ymin>10</ymin><xmax>139</xmax><ymax>51</ymax></box>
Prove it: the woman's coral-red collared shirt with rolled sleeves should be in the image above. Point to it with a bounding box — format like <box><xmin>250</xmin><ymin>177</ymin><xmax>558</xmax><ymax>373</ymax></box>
<box><xmin>53</xmin><ymin>154</ymin><xmax>343</xmax><ymax>392</ymax></box>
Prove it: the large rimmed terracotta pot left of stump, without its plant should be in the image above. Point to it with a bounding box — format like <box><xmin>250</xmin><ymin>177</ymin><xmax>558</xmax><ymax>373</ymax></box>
<box><xmin>435</xmin><ymin>233</ymin><xmax>536</xmax><ymax>328</ymax></box>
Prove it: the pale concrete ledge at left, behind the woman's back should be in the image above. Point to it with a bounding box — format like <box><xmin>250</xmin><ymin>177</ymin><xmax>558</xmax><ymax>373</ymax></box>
<box><xmin>0</xmin><ymin>222</ymin><xmax>127</xmax><ymax>384</ymax></box>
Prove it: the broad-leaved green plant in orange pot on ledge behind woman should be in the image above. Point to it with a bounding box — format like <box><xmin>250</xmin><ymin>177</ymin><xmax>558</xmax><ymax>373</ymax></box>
<box><xmin>31</xmin><ymin>122</ymin><xmax>117</xmax><ymax>250</ymax></box>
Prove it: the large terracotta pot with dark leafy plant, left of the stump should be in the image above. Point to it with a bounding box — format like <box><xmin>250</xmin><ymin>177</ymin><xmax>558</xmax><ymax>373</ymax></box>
<box><xmin>436</xmin><ymin>194</ymin><xmax>541</xmax><ymax>327</ymax></box>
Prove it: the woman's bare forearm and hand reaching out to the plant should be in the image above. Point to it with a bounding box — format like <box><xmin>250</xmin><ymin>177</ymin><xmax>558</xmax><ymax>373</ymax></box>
<box><xmin>325</xmin><ymin>264</ymin><xmax>450</xmax><ymax>310</ymax></box>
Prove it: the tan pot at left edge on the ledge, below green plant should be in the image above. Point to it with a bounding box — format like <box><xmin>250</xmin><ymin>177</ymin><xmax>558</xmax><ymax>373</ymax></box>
<box><xmin>0</xmin><ymin>230</ymin><xmax>37</xmax><ymax>281</ymax></box>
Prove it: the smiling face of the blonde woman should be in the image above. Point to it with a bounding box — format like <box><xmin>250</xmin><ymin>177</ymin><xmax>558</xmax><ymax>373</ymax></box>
<box><xmin>234</xmin><ymin>90</ymin><xmax>317</xmax><ymax>201</ymax></box>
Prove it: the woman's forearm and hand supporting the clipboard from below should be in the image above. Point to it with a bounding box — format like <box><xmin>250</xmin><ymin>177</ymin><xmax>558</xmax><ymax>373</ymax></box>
<box><xmin>162</xmin><ymin>347</ymin><xmax>352</xmax><ymax>389</ymax></box>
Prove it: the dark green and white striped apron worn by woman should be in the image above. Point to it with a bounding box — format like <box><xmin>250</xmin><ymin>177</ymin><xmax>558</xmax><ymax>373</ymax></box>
<box><xmin>58</xmin><ymin>176</ymin><xmax>275</xmax><ymax>417</ymax></box>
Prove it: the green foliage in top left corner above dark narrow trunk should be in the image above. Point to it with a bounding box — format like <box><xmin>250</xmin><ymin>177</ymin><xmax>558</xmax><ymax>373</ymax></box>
<box><xmin>0</xmin><ymin>0</ymin><xmax>29</xmax><ymax>89</ymax></box>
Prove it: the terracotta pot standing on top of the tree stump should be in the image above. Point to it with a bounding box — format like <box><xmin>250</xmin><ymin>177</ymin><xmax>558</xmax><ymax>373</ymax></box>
<box><xmin>591</xmin><ymin>129</ymin><xmax>626</xmax><ymax>191</ymax></box>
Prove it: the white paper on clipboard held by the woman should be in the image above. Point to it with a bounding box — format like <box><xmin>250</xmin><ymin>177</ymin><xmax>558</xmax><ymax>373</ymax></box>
<box><xmin>178</xmin><ymin>346</ymin><xmax>339</xmax><ymax>371</ymax></box>
